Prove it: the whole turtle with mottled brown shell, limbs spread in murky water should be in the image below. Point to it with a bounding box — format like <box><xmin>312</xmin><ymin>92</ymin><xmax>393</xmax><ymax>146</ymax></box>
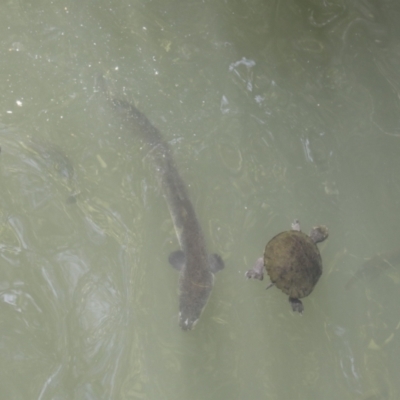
<box><xmin>246</xmin><ymin>220</ymin><xmax>329</xmax><ymax>314</ymax></box>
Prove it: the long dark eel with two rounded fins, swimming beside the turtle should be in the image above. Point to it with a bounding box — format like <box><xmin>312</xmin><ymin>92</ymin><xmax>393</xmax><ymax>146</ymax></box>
<box><xmin>109</xmin><ymin>97</ymin><xmax>224</xmax><ymax>331</ymax></box>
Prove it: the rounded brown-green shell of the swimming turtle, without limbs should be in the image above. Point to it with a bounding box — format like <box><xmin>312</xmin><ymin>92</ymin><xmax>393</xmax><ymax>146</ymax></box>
<box><xmin>264</xmin><ymin>230</ymin><xmax>322</xmax><ymax>299</ymax></box>
